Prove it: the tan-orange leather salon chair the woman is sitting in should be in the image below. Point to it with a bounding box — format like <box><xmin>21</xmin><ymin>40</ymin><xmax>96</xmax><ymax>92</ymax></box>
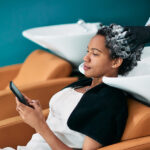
<box><xmin>0</xmin><ymin>98</ymin><xmax>150</xmax><ymax>150</ymax></box>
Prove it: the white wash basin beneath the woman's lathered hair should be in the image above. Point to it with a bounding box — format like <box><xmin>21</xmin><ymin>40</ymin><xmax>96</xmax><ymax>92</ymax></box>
<box><xmin>79</xmin><ymin>47</ymin><xmax>150</xmax><ymax>105</ymax></box>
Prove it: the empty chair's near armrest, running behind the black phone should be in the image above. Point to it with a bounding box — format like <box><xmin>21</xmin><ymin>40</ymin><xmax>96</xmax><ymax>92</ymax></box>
<box><xmin>0</xmin><ymin>77</ymin><xmax>78</xmax><ymax>120</ymax></box>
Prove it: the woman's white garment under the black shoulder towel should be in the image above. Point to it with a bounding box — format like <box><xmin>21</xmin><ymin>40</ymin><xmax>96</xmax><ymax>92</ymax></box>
<box><xmin>3</xmin><ymin>88</ymin><xmax>85</xmax><ymax>150</ymax></box>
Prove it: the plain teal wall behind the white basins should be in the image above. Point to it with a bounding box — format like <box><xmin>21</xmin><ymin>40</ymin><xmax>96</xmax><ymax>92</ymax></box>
<box><xmin>0</xmin><ymin>0</ymin><xmax>150</xmax><ymax>66</ymax></box>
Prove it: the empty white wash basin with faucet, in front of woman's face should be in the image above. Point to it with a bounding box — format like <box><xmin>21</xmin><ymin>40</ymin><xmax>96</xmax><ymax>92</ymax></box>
<box><xmin>23</xmin><ymin>22</ymin><xmax>99</xmax><ymax>67</ymax></box>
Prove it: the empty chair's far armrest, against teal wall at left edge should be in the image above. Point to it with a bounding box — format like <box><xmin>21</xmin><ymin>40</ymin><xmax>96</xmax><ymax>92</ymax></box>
<box><xmin>0</xmin><ymin>64</ymin><xmax>22</xmax><ymax>90</ymax></box>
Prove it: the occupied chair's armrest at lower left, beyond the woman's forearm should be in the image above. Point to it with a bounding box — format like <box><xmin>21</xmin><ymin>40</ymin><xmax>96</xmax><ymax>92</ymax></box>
<box><xmin>0</xmin><ymin>109</ymin><xmax>49</xmax><ymax>148</ymax></box>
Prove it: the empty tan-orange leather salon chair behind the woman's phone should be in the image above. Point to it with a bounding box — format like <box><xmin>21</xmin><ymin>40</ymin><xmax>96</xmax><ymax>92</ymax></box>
<box><xmin>0</xmin><ymin>50</ymin><xmax>77</xmax><ymax>120</ymax></box>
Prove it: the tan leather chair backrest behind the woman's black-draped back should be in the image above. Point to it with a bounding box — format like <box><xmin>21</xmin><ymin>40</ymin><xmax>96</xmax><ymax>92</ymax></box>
<box><xmin>121</xmin><ymin>99</ymin><xmax>150</xmax><ymax>141</ymax></box>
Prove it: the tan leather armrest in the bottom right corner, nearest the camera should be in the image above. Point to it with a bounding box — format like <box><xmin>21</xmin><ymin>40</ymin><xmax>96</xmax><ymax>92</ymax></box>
<box><xmin>98</xmin><ymin>136</ymin><xmax>150</xmax><ymax>150</ymax></box>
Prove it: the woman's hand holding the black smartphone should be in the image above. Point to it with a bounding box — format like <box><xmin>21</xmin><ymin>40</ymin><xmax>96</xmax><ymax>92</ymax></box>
<box><xmin>16</xmin><ymin>95</ymin><xmax>46</xmax><ymax>132</ymax></box>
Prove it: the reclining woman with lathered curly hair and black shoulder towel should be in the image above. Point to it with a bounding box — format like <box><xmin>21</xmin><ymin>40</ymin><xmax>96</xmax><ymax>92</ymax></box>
<box><xmin>1</xmin><ymin>24</ymin><xmax>149</xmax><ymax>150</ymax></box>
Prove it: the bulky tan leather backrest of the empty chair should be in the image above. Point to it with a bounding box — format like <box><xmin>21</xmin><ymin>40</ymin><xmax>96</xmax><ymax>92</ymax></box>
<box><xmin>8</xmin><ymin>50</ymin><xmax>72</xmax><ymax>85</ymax></box>
